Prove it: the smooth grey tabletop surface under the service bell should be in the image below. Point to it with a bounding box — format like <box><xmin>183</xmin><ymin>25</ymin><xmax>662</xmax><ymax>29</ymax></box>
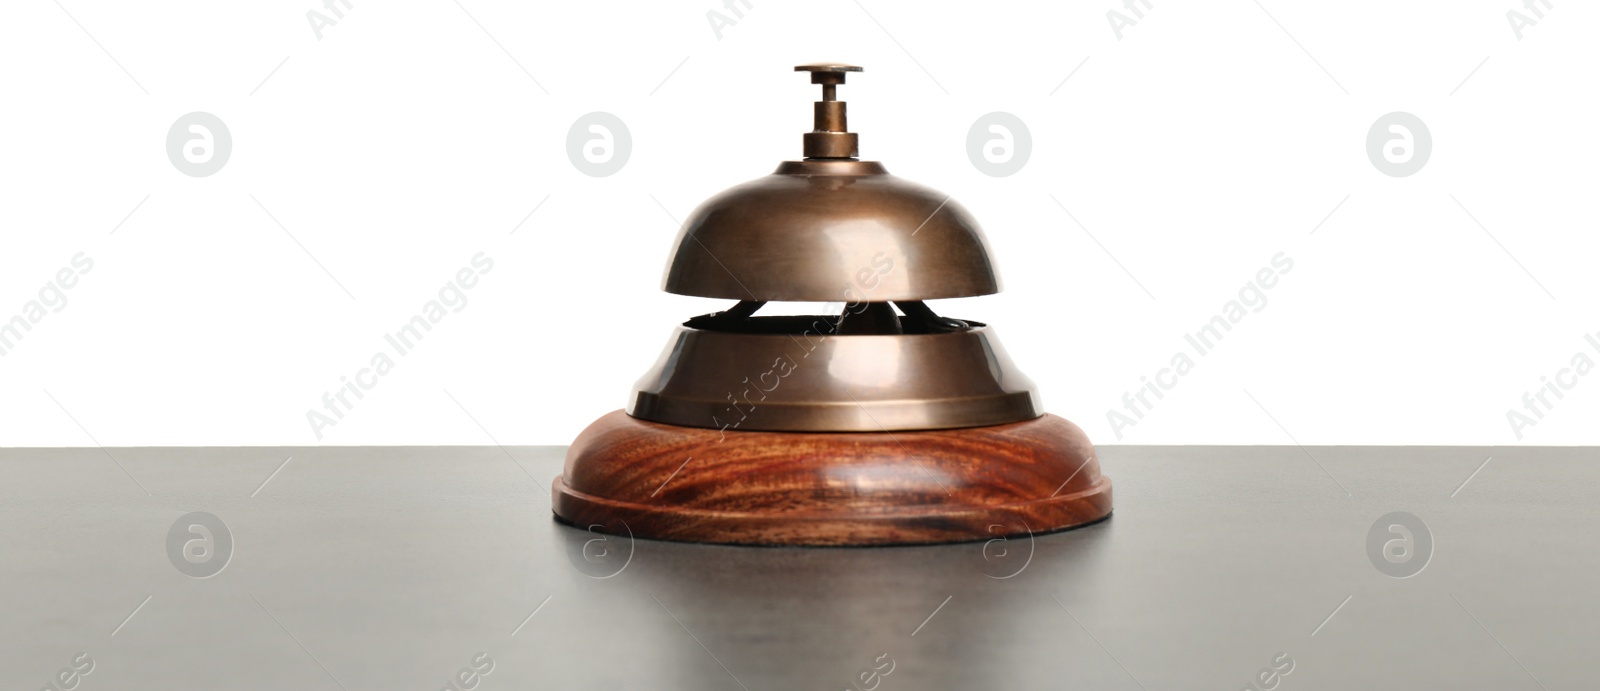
<box><xmin>0</xmin><ymin>446</ymin><xmax>1600</xmax><ymax>691</ymax></box>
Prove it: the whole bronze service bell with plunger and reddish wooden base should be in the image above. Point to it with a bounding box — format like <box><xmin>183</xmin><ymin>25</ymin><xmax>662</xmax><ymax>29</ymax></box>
<box><xmin>552</xmin><ymin>64</ymin><xmax>1112</xmax><ymax>545</ymax></box>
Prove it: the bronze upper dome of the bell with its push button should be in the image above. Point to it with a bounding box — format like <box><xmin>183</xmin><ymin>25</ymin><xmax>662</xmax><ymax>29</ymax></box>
<box><xmin>662</xmin><ymin>64</ymin><xmax>1000</xmax><ymax>302</ymax></box>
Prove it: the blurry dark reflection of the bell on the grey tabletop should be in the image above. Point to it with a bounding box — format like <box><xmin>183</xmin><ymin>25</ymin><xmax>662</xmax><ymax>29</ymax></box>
<box><xmin>558</xmin><ymin>521</ymin><xmax>1131</xmax><ymax>691</ymax></box>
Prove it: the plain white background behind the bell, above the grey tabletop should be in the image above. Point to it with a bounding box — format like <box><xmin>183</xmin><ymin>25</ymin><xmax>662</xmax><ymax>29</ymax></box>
<box><xmin>0</xmin><ymin>0</ymin><xmax>1600</xmax><ymax>446</ymax></box>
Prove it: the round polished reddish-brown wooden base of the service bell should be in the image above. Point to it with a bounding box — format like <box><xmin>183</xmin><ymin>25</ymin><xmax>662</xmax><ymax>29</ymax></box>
<box><xmin>550</xmin><ymin>411</ymin><xmax>1110</xmax><ymax>545</ymax></box>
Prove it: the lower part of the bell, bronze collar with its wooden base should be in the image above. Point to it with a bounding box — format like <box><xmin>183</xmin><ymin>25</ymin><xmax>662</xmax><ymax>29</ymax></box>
<box><xmin>550</xmin><ymin>318</ymin><xmax>1112</xmax><ymax>545</ymax></box>
